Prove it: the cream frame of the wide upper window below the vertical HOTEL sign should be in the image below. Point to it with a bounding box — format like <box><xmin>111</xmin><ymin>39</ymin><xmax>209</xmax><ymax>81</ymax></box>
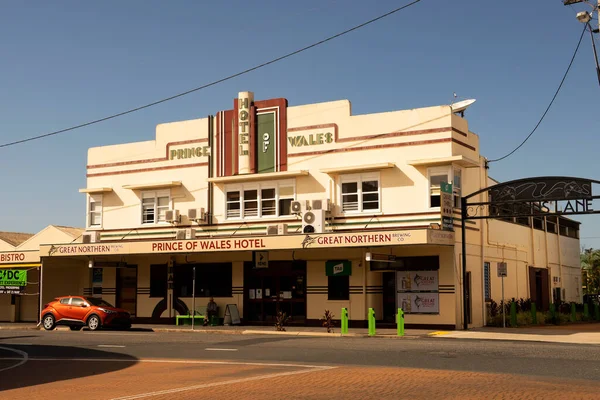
<box><xmin>223</xmin><ymin>180</ymin><xmax>296</xmax><ymax>221</ymax></box>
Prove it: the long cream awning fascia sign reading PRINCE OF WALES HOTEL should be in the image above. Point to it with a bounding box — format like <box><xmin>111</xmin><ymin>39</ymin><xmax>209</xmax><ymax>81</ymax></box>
<box><xmin>40</xmin><ymin>229</ymin><xmax>454</xmax><ymax>257</ymax></box>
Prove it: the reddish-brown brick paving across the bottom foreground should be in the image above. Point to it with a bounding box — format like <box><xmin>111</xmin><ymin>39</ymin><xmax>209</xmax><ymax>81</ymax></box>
<box><xmin>0</xmin><ymin>360</ymin><xmax>600</xmax><ymax>400</ymax></box>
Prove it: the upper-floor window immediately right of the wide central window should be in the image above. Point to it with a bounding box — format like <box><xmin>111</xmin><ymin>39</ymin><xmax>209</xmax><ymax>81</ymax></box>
<box><xmin>341</xmin><ymin>173</ymin><xmax>380</xmax><ymax>213</ymax></box>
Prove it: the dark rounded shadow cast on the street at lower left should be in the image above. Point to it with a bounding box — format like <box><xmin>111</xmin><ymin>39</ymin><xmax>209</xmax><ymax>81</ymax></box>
<box><xmin>0</xmin><ymin>342</ymin><xmax>137</xmax><ymax>390</ymax></box>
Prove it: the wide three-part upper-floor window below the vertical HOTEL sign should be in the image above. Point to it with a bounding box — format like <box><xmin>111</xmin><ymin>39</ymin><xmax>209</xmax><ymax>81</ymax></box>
<box><xmin>225</xmin><ymin>181</ymin><xmax>295</xmax><ymax>218</ymax></box>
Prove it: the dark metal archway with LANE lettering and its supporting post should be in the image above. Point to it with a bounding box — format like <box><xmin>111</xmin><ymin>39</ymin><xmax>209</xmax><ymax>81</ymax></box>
<box><xmin>460</xmin><ymin>176</ymin><xmax>600</xmax><ymax>330</ymax></box>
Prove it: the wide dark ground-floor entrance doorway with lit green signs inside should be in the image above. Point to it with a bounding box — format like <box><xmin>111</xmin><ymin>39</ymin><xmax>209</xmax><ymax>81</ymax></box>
<box><xmin>244</xmin><ymin>261</ymin><xmax>306</xmax><ymax>324</ymax></box>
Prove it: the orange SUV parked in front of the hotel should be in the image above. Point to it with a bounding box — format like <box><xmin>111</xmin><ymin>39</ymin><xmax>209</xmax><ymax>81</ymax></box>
<box><xmin>40</xmin><ymin>296</ymin><xmax>131</xmax><ymax>331</ymax></box>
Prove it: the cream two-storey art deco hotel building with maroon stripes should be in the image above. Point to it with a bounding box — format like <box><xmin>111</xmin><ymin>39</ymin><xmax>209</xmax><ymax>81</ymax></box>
<box><xmin>0</xmin><ymin>92</ymin><xmax>581</xmax><ymax>329</ymax></box>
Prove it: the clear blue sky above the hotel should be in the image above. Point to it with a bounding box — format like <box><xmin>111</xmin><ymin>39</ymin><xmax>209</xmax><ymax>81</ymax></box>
<box><xmin>0</xmin><ymin>0</ymin><xmax>600</xmax><ymax>247</ymax></box>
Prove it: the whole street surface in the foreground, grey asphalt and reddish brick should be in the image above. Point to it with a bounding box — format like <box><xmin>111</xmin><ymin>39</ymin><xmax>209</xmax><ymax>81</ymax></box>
<box><xmin>0</xmin><ymin>331</ymin><xmax>600</xmax><ymax>399</ymax></box>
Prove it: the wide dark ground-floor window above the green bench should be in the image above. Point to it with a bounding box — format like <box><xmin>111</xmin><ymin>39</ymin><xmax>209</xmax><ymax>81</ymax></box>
<box><xmin>173</xmin><ymin>263</ymin><xmax>232</xmax><ymax>297</ymax></box>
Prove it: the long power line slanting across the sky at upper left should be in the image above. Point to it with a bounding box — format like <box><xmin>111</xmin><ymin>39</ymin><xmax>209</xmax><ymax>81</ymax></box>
<box><xmin>0</xmin><ymin>0</ymin><xmax>421</xmax><ymax>148</ymax></box>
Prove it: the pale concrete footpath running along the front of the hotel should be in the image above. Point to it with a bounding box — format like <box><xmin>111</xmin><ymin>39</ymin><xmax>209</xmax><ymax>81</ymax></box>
<box><xmin>0</xmin><ymin>323</ymin><xmax>600</xmax><ymax>345</ymax></box>
